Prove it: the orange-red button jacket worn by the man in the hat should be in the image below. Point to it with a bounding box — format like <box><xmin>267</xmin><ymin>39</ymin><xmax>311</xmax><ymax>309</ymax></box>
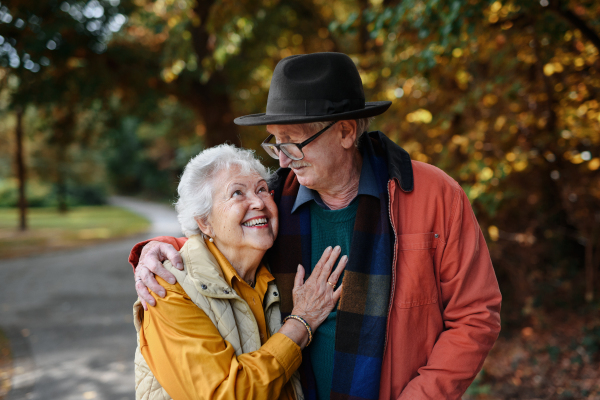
<box><xmin>129</xmin><ymin>138</ymin><xmax>502</xmax><ymax>400</ymax></box>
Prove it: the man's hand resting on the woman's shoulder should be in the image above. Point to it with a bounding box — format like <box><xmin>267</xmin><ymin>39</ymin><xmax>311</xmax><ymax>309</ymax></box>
<box><xmin>135</xmin><ymin>241</ymin><xmax>183</xmax><ymax>310</ymax></box>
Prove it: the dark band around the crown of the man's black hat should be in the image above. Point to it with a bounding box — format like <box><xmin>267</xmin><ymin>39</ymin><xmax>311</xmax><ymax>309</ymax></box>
<box><xmin>267</xmin><ymin>99</ymin><xmax>365</xmax><ymax>116</ymax></box>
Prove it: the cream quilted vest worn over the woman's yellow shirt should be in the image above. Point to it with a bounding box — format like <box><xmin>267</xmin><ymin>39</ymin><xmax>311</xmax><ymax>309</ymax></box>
<box><xmin>133</xmin><ymin>236</ymin><xmax>304</xmax><ymax>400</ymax></box>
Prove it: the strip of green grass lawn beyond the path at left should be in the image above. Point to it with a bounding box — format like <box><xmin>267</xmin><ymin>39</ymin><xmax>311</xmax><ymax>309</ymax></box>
<box><xmin>0</xmin><ymin>206</ymin><xmax>150</xmax><ymax>259</ymax></box>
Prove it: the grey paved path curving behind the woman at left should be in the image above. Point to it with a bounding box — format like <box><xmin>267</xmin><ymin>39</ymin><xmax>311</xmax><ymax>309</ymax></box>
<box><xmin>0</xmin><ymin>197</ymin><xmax>181</xmax><ymax>400</ymax></box>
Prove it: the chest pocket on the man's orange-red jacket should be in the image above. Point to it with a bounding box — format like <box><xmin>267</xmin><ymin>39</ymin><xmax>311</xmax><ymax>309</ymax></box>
<box><xmin>394</xmin><ymin>232</ymin><xmax>438</xmax><ymax>308</ymax></box>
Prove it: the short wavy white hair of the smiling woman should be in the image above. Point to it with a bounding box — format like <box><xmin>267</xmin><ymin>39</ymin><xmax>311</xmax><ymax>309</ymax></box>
<box><xmin>175</xmin><ymin>144</ymin><xmax>270</xmax><ymax>237</ymax></box>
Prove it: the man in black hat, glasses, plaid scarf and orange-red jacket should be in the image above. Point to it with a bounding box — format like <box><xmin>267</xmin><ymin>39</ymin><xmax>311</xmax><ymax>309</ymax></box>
<box><xmin>130</xmin><ymin>53</ymin><xmax>501</xmax><ymax>400</ymax></box>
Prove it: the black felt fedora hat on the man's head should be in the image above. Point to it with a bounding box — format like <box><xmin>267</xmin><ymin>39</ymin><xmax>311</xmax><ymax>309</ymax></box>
<box><xmin>234</xmin><ymin>53</ymin><xmax>392</xmax><ymax>125</ymax></box>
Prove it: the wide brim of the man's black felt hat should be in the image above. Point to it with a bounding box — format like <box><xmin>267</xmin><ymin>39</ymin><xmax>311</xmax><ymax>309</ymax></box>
<box><xmin>233</xmin><ymin>101</ymin><xmax>392</xmax><ymax>126</ymax></box>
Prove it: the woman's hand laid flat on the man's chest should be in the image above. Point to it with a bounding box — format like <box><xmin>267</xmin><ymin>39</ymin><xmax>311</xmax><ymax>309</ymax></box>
<box><xmin>292</xmin><ymin>246</ymin><xmax>348</xmax><ymax>332</ymax></box>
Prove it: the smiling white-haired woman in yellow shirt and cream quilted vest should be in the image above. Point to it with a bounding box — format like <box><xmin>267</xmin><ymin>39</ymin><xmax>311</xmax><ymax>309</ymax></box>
<box><xmin>134</xmin><ymin>145</ymin><xmax>347</xmax><ymax>400</ymax></box>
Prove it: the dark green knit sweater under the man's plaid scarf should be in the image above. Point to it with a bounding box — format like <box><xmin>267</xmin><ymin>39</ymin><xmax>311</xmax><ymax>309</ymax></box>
<box><xmin>308</xmin><ymin>200</ymin><xmax>358</xmax><ymax>400</ymax></box>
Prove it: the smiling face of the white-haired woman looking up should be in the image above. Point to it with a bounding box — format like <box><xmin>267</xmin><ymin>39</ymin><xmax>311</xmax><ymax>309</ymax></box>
<box><xmin>200</xmin><ymin>167</ymin><xmax>279</xmax><ymax>261</ymax></box>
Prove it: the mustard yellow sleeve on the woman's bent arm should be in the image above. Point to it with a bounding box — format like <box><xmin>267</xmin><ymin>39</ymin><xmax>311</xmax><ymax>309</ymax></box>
<box><xmin>140</xmin><ymin>276</ymin><xmax>302</xmax><ymax>400</ymax></box>
